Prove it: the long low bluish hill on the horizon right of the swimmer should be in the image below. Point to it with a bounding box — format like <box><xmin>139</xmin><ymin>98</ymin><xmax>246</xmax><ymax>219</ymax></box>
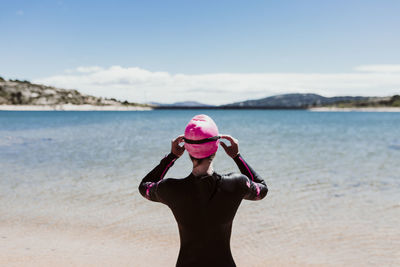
<box><xmin>222</xmin><ymin>94</ymin><xmax>370</xmax><ymax>108</ymax></box>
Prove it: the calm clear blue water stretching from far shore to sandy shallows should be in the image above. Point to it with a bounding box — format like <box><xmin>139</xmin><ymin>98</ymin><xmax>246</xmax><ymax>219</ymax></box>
<box><xmin>0</xmin><ymin>110</ymin><xmax>400</xmax><ymax>266</ymax></box>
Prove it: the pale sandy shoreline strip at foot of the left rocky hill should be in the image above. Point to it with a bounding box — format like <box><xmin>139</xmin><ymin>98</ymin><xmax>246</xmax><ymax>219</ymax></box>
<box><xmin>0</xmin><ymin>104</ymin><xmax>153</xmax><ymax>111</ymax></box>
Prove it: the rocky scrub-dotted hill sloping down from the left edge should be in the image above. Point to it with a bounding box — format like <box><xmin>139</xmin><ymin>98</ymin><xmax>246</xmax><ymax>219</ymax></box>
<box><xmin>0</xmin><ymin>77</ymin><xmax>149</xmax><ymax>107</ymax></box>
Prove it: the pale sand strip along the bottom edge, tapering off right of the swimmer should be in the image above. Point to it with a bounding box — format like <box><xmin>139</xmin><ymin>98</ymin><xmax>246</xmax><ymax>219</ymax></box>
<box><xmin>0</xmin><ymin>216</ymin><xmax>312</xmax><ymax>267</ymax></box>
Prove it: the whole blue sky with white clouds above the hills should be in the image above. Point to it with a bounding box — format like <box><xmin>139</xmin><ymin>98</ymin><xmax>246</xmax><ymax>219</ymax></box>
<box><xmin>0</xmin><ymin>0</ymin><xmax>400</xmax><ymax>103</ymax></box>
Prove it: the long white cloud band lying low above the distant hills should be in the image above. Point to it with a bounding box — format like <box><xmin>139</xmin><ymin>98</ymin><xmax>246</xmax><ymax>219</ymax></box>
<box><xmin>34</xmin><ymin>65</ymin><xmax>400</xmax><ymax>104</ymax></box>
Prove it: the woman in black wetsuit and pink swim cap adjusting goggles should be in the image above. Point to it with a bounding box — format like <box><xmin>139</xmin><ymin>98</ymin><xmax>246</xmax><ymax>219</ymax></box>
<box><xmin>139</xmin><ymin>115</ymin><xmax>268</xmax><ymax>266</ymax></box>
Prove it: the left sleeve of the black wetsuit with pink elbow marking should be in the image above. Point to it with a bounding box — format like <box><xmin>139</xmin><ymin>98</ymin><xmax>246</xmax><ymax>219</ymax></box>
<box><xmin>139</xmin><ymin>153</ymin><xmax>178</xmax><ymax>202</ymax></box>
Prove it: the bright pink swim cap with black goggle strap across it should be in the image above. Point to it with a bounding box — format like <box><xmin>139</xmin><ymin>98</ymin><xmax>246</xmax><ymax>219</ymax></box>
<box><xmin>185</xmin><ymin>114</ymin><xmax>219</xmax><ymax>159</ymax></box>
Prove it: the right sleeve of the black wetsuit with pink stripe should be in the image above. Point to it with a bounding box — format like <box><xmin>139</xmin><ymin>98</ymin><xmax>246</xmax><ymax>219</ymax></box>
<box><xmin>233</xmin><ymin>154</ymin><xmax>268</xmax><ymax>200</ymax></box>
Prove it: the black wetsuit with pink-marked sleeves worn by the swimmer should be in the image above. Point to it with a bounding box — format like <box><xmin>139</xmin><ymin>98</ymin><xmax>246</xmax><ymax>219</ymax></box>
<box><xmin>139</xmin><ymin>153</ymin><xmax>268</xmax><ymax>267</ymax></box>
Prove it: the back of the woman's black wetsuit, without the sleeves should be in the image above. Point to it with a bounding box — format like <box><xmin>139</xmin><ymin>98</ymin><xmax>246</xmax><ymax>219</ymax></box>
<box><xmin>159</xmin><ymin>173</ymin><xmax>247</xmax><ymax>266</ymax></box>
